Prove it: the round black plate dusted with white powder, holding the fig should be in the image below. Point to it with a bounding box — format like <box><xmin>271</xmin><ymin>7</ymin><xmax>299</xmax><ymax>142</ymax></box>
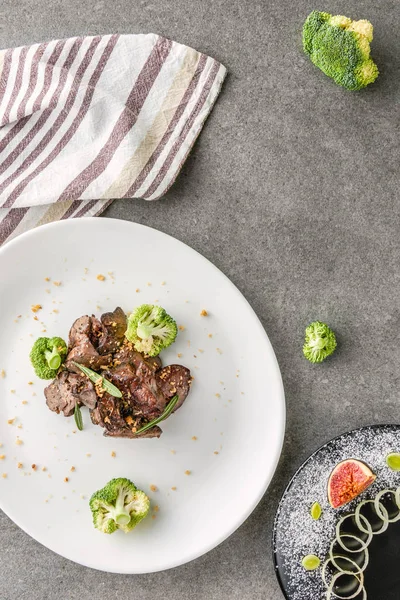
<box><xmin>273</xmin><ymin>425</ymin><xmax>400</xmax><ymax>600</ymax></box>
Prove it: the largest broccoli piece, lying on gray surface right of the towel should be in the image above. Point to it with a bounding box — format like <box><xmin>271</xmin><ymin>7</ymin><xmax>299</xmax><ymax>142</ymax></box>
<box><xmin>303</xmin><ymin>10</ymin><xmax>379</xmax><ymax>90</ymax></box>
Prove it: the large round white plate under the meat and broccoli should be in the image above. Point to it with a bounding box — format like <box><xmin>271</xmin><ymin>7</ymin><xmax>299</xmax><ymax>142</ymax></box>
<box><xmin>0</xmin><ymin>219</ymin><xmax>285</xmax><ymax>573</ymax></box>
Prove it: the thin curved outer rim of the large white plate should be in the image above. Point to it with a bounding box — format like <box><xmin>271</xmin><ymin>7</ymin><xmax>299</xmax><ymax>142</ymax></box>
<box><xmin>0</xmin><ymin>217</ymin><xmax>287</xmax><ymax>575</ymax></box>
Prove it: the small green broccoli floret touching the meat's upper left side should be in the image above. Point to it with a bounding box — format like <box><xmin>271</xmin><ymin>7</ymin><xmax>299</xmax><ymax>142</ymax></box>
<box><xmin>29</xmin><ymin>337</ymin><xmax>68</xmax><ymax>379</ymax></box>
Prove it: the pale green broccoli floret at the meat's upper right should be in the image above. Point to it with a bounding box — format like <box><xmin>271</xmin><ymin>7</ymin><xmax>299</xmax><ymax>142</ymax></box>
<box><xmin>125</xmin><ymin>304</ymin><xmax>178</xmax><ymax>356</ymax></box>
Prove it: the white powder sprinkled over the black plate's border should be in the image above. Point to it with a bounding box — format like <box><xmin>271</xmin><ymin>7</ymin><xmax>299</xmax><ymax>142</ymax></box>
<box><xmin>274</xmin><ymin>425</ymin><xmax>400</xmax><ymax>600</ymax></box>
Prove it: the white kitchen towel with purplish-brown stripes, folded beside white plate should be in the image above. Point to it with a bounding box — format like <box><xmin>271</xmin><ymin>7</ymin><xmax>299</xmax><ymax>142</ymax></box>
<box><xmin>0</xmin><ymin>34</ymin><xmax>226</xmax><ymax>244</ymax></box>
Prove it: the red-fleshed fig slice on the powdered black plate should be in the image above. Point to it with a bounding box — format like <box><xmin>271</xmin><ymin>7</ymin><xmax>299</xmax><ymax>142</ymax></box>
<box><xmin>328</xmin><ymin>458</ymin><xmax>376</xmax><ymax>508</ymax></box>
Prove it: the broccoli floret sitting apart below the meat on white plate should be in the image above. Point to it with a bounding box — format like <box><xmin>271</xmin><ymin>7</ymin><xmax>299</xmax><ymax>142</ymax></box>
<box><xmin>89</xmin><ymin>477</ymin><xmax>150</xmax><ymax>533</ymax></box>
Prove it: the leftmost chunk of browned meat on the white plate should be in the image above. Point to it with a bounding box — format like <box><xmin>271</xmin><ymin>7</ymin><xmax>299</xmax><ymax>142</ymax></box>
<box><xmin>44</xmin><ymin>371</ymin><xmax>97</xmax><ymax>417</ymax></box>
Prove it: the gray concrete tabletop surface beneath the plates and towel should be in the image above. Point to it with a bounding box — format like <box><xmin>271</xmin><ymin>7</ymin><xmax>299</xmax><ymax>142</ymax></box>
<box><xmin>0</xmin><ymin>0</ymin><xmax>400</xmax><ymax>600</ymax></box>
